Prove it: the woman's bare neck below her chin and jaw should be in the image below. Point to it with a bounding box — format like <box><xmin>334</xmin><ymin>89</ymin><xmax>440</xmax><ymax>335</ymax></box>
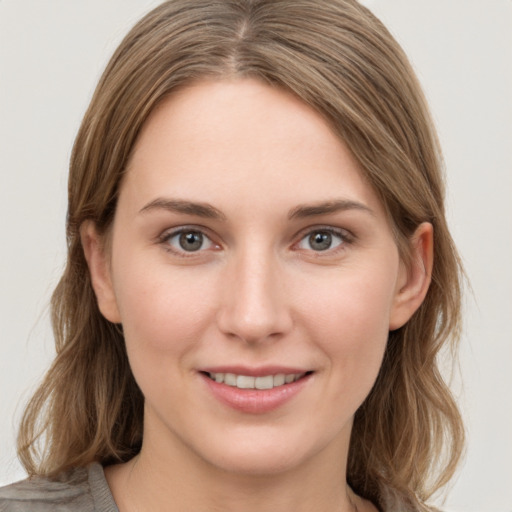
<box><xmin>105</xmin><ymin>410</ymin><xmax>374</xmax><ymax>512</ymax></box>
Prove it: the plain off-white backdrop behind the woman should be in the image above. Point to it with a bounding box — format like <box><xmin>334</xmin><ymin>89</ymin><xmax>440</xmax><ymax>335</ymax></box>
<box><xmin>0</xmin><ymin>0</ymin><xmax>512</xmax><ymax>512</ymax></box>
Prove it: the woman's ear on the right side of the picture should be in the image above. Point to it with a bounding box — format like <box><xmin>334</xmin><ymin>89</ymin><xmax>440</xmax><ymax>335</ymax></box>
<box><xmin>389</xmin><ymin>222</ymin><xmax>434</xmax><ymax>331</ymax></box>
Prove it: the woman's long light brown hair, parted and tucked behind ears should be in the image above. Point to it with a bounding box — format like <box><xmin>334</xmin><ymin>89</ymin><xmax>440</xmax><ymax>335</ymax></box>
<box><xmin>18</xmin><ymin>0</ymin><xmax>464</xmax><ymax>510</ymax></box>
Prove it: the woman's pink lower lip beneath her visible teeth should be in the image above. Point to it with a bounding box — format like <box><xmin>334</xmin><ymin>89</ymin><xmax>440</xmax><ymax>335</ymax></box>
<box><xmin>201</xmin><ymin>374</ymin><xmax>311</xmax><ymax>414</ymax></box>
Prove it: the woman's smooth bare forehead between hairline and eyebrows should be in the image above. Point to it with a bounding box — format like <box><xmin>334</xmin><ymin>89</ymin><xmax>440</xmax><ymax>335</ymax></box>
<box><xmin>124</xmin><ymin>79</ymin><xmax>380</xmax><ymax>217</ymax></box>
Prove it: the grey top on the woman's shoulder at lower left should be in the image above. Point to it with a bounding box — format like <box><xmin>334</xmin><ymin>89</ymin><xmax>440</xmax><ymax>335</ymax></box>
<box><xmin>0</xmin><ymin>462</ymin><xmax>119</xmax><ymax>512</ymax></box>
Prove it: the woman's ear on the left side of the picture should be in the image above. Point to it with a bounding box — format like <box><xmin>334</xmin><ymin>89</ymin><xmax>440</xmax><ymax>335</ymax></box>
<box><xmin>80</xmin><ymin>221</ymin><xmax>121</xmax><ymax>324</ymax></box>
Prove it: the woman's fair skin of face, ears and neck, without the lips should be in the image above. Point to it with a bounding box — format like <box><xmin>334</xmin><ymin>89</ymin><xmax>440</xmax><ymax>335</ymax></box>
<box><xmin>82</xmin><ymin>79</ymin><xmax>432</xmax><ymax>512</ymax></box>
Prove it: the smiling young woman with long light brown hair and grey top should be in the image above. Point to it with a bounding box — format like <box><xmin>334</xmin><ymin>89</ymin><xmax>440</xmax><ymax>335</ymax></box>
<box><xmin>0</xmin><ymin>0</ymin><xmax>463</xmax><ymax>512</ymax></box>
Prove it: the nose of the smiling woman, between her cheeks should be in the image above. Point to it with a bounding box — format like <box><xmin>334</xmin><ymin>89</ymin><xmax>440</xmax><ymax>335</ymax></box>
<box><xmin>217</xmin><ymin>247</ymin><xmax>293</xmax><ymax>343</ymax></box>
